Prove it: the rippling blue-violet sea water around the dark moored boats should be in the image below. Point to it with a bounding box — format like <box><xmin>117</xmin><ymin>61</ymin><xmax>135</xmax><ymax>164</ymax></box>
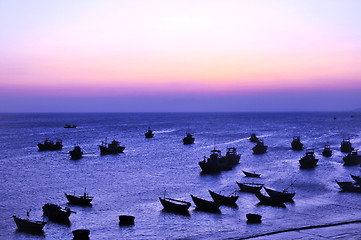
<box><xmin>0</xmin><ymin>112</ymin><xmax>361</xmax><ymax>239</ymax></box>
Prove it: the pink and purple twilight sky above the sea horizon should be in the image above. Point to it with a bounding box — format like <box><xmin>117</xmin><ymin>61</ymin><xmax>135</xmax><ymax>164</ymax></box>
<box><xmin>0</xmin><ymin>0</ymin><xmax>361</xmax><ymax>112</ymax></box>
